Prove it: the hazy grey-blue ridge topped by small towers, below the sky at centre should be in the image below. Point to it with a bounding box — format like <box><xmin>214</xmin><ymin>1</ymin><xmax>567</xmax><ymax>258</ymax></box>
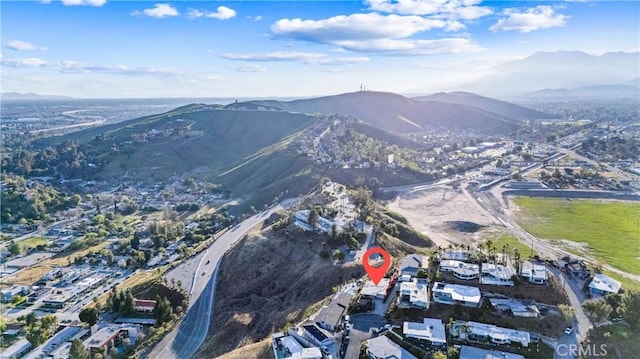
<box><xmin>228</xmin><ymin>91</ymin><xmax>549</xmax><ymax>133</ymax></box>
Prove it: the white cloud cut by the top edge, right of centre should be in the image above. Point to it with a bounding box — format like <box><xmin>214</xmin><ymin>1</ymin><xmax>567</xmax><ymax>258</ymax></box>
<box><xmin>366</xmin><ymin>0</ymin><xmax>493</xmax><ymax>20</ymax></box>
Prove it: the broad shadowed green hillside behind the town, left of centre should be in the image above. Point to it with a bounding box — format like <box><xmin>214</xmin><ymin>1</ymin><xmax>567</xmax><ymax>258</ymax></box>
<box><xmin>35</xmin><ymin>105</ymin><xmax>314</xmax><ymax>181</ymax></box>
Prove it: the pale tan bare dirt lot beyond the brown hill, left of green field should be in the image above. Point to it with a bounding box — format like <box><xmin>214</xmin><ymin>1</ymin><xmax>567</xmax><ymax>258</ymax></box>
<box><xmin>388</xmin><ymin>185</ymin><xmax>494</xmax><ymax>246</ymax></box>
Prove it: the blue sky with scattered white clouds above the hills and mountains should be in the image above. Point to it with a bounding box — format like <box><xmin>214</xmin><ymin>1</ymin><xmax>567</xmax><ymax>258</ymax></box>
<box><xmin>0</xmin><ymin>0</ymin><xmax>640</xmax><ymax>97</ymax></box>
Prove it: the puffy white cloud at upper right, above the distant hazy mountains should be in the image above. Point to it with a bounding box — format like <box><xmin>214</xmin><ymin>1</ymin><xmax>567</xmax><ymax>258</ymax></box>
<box><xmin>489</xmin><ymin>5</ymin><xmax>570</xmax><ymax>32</ymax></box>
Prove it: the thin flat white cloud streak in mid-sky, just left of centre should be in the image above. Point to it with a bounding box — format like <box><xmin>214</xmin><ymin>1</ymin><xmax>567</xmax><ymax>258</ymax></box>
<box><xmin>222</xmin><ymin>51</ymin><xmax>370</xmax><ymax>65</ymax></box>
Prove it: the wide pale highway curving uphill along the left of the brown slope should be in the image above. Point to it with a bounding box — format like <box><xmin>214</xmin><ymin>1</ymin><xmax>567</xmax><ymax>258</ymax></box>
<box><xmin>141</xmin><ymin>201</ymin><xmax>297</xmax><ymax>359</ymax></box>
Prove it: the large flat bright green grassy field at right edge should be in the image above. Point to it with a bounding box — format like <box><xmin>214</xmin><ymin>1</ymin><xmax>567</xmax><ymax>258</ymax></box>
<box><xmin>514</xmin><ymin>197</ymin><xmax>640</xmax><ymax>274</ymax></box>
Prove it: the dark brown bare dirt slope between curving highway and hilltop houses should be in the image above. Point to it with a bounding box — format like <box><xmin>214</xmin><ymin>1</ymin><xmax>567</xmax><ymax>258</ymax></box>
<box><xmin>195</xmin><ymin>229</ymin><xmax>364</xmax><ymax>358</ymax></box>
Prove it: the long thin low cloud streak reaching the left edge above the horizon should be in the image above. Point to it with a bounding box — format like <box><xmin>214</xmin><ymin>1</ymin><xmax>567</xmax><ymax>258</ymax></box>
<box><xmin>1</xmin><ymin>58</ymin><xmax>180</xmax><ymax>76</ymax></box>
